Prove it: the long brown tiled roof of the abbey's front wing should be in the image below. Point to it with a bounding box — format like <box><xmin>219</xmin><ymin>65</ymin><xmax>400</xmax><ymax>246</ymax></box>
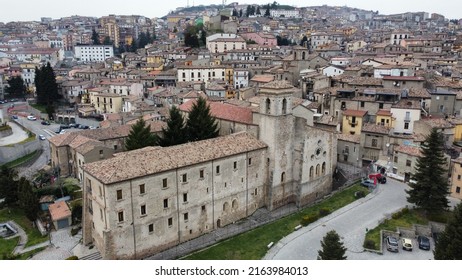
<box><xmin>84</xmin><ymin>132</ymin><xmax>267</xmax><ymax>184</ymax></box>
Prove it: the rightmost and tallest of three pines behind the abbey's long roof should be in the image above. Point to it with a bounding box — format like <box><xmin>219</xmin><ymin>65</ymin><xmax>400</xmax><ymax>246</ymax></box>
<box><xmin>186</xmin><ymin>97</ymin><xmax>219</xmax><ymax>142</ymax></box>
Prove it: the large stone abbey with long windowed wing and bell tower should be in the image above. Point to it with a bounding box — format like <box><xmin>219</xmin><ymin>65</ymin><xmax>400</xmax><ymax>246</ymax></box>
<box><xmin>83</xmin><ymin>81</ymin><xmax>337</xmax><ymax>259</ymax></box>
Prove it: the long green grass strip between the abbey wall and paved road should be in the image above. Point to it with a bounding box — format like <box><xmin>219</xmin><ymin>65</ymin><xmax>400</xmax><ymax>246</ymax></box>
<box><xmin>184</xmin><ymin>185</ymin><xmax>368</xmax><ymax>260</ymax></box>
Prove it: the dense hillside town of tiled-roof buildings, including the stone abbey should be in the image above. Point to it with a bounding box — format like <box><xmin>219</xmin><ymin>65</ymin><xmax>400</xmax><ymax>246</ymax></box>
<box><xmin>0</xmin><ymin>2</ymin><xmax>462</xmax><ymax>259</ymax></box>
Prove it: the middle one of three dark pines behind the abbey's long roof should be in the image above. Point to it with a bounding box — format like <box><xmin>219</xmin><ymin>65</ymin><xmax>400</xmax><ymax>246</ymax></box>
<box><xmin>157</xmin><ymin>106</ymin><xmax>188</xmax><ymax>147</ymax></box>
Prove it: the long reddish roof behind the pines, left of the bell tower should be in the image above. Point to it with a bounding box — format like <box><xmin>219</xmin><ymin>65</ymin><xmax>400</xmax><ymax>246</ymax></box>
<box><xmin>180</xmin><ymin>100</ymin><xmax>253</xmax><ymax>124</ymax></box>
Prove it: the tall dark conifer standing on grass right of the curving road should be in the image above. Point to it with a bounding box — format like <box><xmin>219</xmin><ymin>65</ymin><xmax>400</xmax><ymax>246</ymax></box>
<box><xmin>406</xmin><ymin>129</ymin><xmax>449</xmax><ymax>213</ymax></box>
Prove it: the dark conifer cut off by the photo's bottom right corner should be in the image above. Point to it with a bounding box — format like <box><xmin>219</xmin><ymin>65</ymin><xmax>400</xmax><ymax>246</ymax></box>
<box><xmin>433</xmin><ymin>203</ymin><xmax>462</xmax><ymax>260</ymax></box>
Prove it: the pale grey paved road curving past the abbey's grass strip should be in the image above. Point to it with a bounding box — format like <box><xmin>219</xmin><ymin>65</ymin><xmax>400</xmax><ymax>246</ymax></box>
<box><xmin>265</xmin><ymin>180</ymin><xmax>414</xmax><ymax>260</ymax></box>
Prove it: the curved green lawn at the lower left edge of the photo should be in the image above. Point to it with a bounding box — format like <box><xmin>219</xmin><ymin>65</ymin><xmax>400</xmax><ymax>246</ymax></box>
<box><xmin>0</xmin><ymin>208</ymin><xmax>48</xmax><ymax>247</ymax></box>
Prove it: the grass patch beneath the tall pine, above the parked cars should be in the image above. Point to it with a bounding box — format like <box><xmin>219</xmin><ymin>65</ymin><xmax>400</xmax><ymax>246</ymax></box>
<box><xmin>364</xmin><ymin>209</ymin><xmax>450</xmax><ymax>250</ymax></box>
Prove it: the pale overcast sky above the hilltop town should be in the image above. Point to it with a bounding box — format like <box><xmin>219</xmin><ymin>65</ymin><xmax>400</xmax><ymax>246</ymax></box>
<box><xmin>0</xmin><ymin>0</ymin><xmax>462</xmax><ymax>22</ymax></box>
